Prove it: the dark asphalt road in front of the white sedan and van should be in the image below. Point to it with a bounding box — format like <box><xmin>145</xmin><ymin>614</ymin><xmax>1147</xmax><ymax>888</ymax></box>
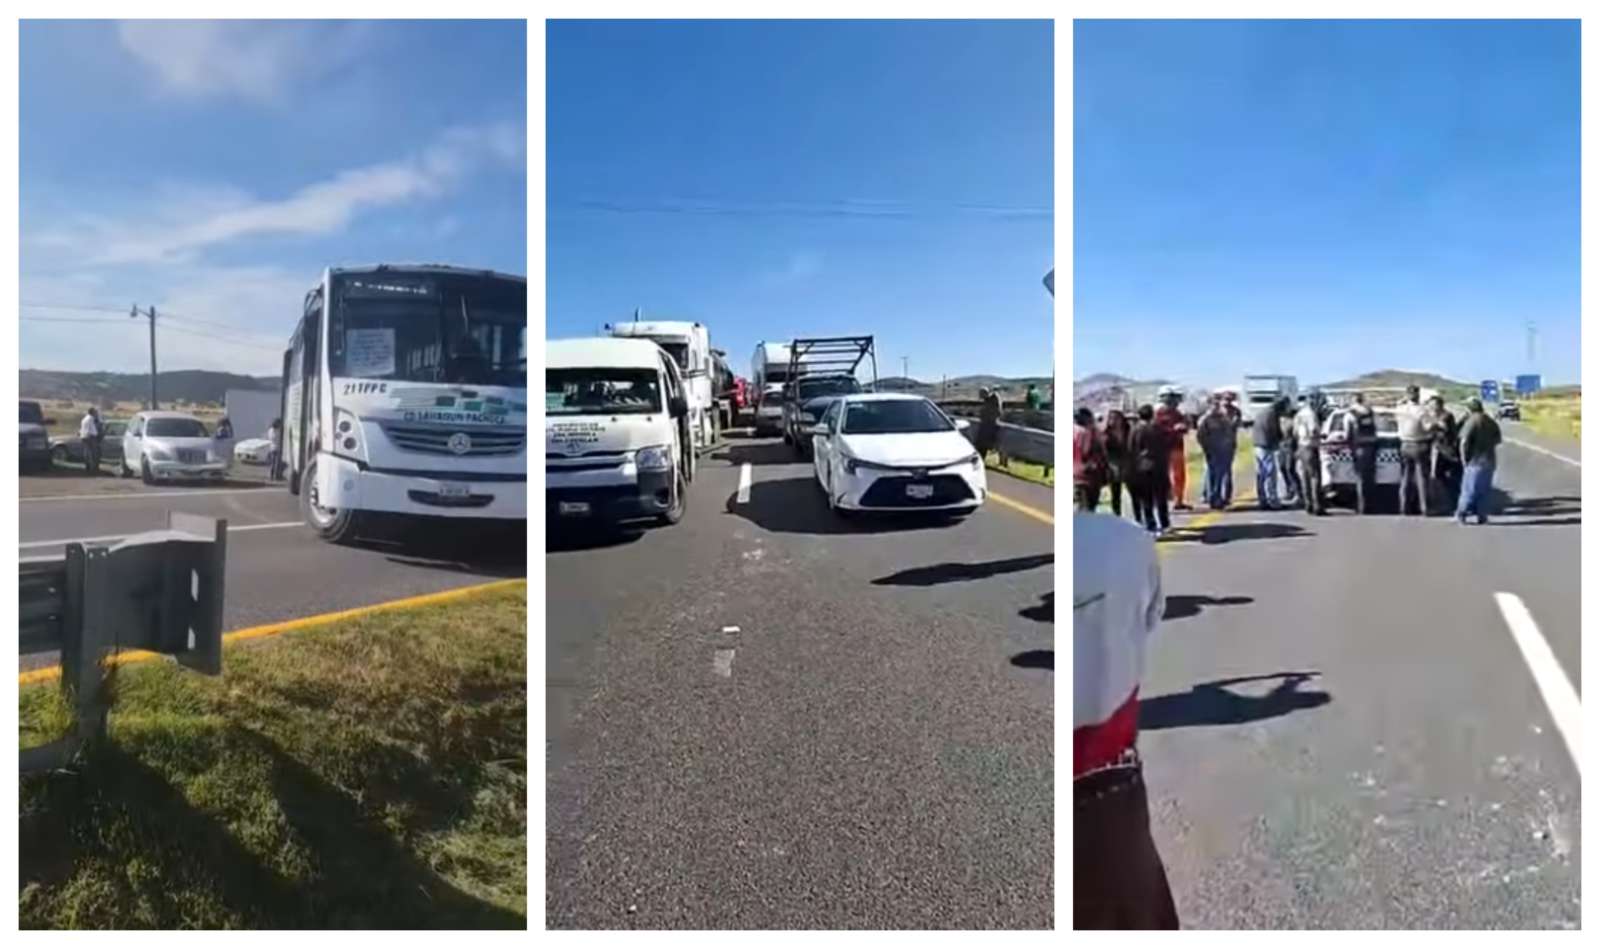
<box><xmin>546</xmin><ymin>438</ymin><xmax>1054</xmax><ymax>928</ymax></box>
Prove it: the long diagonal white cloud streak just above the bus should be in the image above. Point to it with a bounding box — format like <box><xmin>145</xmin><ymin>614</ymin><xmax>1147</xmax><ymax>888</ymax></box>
<box><xmin>34</xmin><ymin>122</ymin><xmax>526</xmax><ymax>266</ymax></box>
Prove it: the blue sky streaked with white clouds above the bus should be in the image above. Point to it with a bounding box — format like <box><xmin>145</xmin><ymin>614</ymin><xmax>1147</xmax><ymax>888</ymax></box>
<box><xmin>21</xmin><ymin>21</ymin><xmax>528</xmax><ymax>374</ymax></box>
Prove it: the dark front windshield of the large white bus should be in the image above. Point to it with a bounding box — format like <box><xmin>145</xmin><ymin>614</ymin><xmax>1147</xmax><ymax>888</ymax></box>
<box><xmin>328</xmin><ymin>272</ymin><xmax>528</xmax><ymax>389</ymax></box>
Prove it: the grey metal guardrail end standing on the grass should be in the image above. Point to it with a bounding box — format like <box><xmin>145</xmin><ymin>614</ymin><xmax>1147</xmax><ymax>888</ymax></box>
<box><xmin>18</xmin><ymin>512</ymin><xmax>227</xmax><ymax>773</ymax></box>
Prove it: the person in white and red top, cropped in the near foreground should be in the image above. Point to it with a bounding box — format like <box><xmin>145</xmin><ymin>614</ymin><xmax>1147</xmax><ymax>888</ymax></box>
<box><xmin>1072</xmin><ymin>514</ymin><xmax>1178</xmax><ymax>930</ymax></box>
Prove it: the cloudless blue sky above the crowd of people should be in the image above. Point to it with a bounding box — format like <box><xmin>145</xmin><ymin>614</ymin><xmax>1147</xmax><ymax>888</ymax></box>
<box><xmin>1072</xmin><ymin>21</ymin><xmax>1579</xmax><ymax>386</ymax></box>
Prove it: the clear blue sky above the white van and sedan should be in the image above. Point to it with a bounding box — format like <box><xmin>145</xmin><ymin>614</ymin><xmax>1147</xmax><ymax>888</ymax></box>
<box><xmin>546</xmin><ymin>21</ymin><xmax>1054</xmax><ymax>379</ymax></box>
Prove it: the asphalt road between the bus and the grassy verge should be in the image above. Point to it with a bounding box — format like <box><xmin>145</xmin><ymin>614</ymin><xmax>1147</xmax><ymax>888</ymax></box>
<box><xmin>18</xmin><ymin>479</ymin><xmax>526</xmax><ymax>669</ymax></box>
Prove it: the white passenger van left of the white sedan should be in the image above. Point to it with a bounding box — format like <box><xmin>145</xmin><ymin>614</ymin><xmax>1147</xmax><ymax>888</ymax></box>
<box><xmin>544</xmin><ymin>338</ymin><xmax>694</xmax><ymax>527</ymax></box>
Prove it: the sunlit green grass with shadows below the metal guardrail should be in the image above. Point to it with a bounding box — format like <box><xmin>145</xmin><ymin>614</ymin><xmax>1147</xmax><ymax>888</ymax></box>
<box><xmin>19</xmin><ymin>586</ymin><xmax>528</xmax><ymax>928</ymax></box>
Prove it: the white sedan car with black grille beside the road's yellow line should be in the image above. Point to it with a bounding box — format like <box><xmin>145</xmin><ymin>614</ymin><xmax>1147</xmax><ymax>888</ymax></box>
<box><xmin>811</xmin><ymin>394</ymin><xmax>989</xmax><ymax>514</ymax></box>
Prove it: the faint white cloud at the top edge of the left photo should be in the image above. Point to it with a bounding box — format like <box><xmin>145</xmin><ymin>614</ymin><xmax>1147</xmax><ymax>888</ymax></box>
<box><xmin>117</xmin><ymin>19</ymin><xmax>368</xmax><ymax>106</ymax></box>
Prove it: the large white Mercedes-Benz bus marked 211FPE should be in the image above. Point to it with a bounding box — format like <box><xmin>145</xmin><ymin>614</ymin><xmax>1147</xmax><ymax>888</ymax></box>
<box><xmin>280</xmin><ymin>264</ymin><xmax>528</xmax><ymax>543</ymax></box>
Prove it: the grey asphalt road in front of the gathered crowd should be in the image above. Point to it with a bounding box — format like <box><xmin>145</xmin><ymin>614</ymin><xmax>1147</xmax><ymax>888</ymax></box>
<box><xmin>1141</xmin><ymin>424</ymin><xmax>1582</xmax><ymax>928</ymax></box>
